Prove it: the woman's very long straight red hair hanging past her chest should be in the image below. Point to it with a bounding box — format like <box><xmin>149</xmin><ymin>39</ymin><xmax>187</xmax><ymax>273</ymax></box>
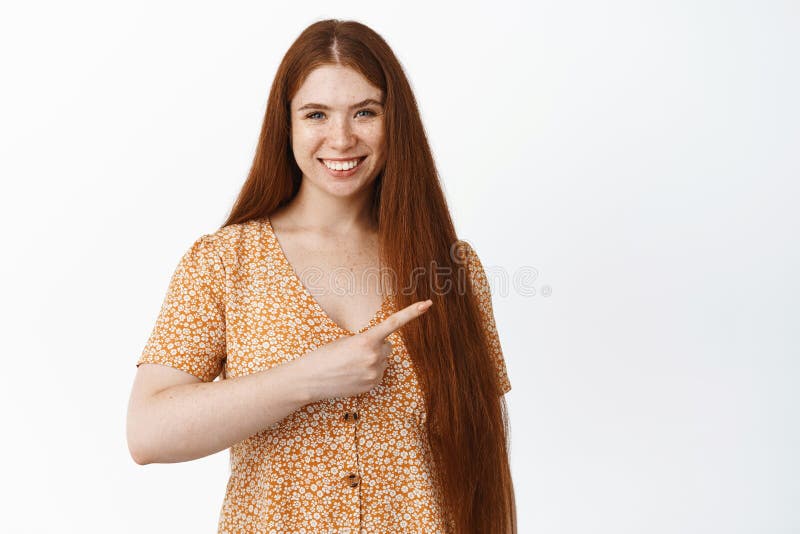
<box><xmin>223</xmin><ymin>20</ymin><xmax>517</xmax><ymax>534</ymax></box>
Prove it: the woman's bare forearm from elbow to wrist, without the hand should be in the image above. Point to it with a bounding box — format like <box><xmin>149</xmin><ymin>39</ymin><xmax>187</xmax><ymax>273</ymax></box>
<box><xmin>130</xmin><ymin>359</ymin><xmax>312</xmax><ymax>464</ymax></box>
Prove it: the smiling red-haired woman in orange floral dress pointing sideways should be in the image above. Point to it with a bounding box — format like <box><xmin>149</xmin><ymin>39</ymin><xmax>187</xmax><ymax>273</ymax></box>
<box><xmin>128</xmin><ymin>20</ymin><xmax>516</xmax><ymax>533</ymax></box>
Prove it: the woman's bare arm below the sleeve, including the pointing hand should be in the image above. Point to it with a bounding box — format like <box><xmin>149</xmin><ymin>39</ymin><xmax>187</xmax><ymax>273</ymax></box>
<box><xmin>128</xmin><ymin>301</ymin><xmax>432</xmax><ymax>464</ymax></box>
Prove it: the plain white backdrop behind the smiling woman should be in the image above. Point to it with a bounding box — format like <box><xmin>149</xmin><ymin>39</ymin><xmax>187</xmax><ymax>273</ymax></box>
<box><xmin>0</xmin><ymin>0</ymin><xmax>800</xmax><ymax>534</ymax></box>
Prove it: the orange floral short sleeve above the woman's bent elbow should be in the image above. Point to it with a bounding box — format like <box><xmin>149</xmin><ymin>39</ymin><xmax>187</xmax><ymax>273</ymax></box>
<box><xmin>136</xmin><ymin>235</ymin><xmax>226</xmax><ymax>382</ymax></box>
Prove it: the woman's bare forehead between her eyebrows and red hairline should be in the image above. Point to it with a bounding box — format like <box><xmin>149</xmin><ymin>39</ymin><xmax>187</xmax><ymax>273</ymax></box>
<box><xmin>292</xmin><ymin>65</ymin><xmax>382</xmax><ymax>109</ymax></box>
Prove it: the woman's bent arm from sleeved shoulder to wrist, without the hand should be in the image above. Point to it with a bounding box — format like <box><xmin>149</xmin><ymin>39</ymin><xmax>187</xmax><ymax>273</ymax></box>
<box><xmin>127</xmin><ymin>236</ymin><xmax>309</xmax><ymax>464</ymax></box>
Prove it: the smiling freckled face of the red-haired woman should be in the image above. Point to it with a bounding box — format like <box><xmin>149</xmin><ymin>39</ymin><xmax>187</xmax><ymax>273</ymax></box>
<box><xmin>290</xmin><ymin>65</ymin><xmax>386</xmax><ymax>197</ymax></box>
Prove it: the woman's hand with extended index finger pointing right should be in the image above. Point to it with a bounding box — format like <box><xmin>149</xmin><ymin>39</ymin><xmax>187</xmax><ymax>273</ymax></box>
<box><xmin>300</xmin><ymin>299</ymin><xmax>433</xmax><ymax>402</ymax></box>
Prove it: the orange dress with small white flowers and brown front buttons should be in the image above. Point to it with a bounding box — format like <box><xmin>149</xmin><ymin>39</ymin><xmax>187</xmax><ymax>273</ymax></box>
<box><xmin>137</xmin><ymin>217</ymin><xmax>511</xmax><ymax>534</ymax></box>
